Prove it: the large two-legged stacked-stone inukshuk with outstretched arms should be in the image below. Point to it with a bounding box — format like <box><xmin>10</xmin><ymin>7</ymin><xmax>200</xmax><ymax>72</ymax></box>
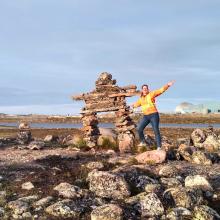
<box><xmin>73</xmin><ymin>72</ymin><xmax>138</xmax><ymax>152</ymax></box>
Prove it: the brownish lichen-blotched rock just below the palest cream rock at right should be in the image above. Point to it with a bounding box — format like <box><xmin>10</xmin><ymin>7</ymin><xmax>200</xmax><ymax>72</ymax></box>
<box><xmin>164</xmin><ymin>187</ymin><xmax>204</xmax><ymax>209</ymax></box>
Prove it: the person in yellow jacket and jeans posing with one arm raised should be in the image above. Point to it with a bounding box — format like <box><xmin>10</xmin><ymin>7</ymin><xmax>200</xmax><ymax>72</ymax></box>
<box><xmin>131</xmin><ymin>81</ymin><xmax>174</xmax><ymax>150</ymax></box>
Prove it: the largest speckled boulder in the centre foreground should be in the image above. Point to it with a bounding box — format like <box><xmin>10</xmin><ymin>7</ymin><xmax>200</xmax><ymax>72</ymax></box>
<box><xmin>88</xmin><ymin>170</ymin><xmax>130</xmax><ymax>200</ymax></box>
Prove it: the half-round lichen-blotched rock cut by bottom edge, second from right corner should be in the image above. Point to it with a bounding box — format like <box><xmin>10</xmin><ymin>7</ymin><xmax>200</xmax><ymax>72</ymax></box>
<box><xmin>166</xmin><ymin>207</ymin><xmax>192</xmax><ymax>220</ymax></box>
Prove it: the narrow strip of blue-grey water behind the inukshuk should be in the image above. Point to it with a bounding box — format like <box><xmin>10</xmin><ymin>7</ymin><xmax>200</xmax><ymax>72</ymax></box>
<box><xmin>0</xmin><ymin>122</ymin><xmax>220</xmax><ymax>129</ymax></box>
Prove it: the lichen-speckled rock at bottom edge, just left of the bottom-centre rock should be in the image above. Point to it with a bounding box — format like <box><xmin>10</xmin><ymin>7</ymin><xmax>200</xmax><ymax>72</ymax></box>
<box><xmin>45</xmin><ymin>199</ymin><xmax>83</xmax><ymax>219</ymax></box>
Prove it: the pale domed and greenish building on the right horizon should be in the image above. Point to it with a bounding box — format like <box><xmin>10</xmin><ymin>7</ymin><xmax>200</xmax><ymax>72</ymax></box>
<box><xmin>175</xmin><ymin>102</ymin><xmax>220</xmax><ymax>114</ymax></box>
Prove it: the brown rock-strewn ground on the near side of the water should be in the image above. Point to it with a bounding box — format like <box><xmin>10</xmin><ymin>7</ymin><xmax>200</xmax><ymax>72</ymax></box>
<box><xmin>0</xmin><ymin>125</ymin><xmax>220</xmax><ymax>220</ymax></box>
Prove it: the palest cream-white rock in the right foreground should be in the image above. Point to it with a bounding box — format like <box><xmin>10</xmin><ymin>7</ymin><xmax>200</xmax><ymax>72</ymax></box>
<box><xmin>185</xmin><ymin>175</ymin><xmax>213</xmax><ymax>191</ymax></box>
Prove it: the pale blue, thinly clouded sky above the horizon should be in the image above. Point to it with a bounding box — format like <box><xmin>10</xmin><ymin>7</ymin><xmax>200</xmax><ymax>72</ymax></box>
<box><xmin>0</xmin><ymin>0</ymin><xmax>220</xmax><ymax>114</ymax></box>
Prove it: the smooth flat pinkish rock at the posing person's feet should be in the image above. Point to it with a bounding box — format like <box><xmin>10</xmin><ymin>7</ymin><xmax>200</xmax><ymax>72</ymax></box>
<box><xmin>135</xmin><ymin>150</ymin><xmax>166</xmax><ymax>164</ymax></box>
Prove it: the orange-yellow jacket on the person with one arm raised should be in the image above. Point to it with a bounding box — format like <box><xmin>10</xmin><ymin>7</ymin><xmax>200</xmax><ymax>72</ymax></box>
<box><xmin>134</xmin><ymin>85</ymin><xmax>169</xmax><ymax>115</ymax></box>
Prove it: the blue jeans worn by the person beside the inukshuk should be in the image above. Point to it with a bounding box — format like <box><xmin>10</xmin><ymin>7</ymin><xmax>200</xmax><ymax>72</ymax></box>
<box><xmin>137</xmin><ymin>112</ymin><xmax>161</xmax><ymax>148</ymax></box>
